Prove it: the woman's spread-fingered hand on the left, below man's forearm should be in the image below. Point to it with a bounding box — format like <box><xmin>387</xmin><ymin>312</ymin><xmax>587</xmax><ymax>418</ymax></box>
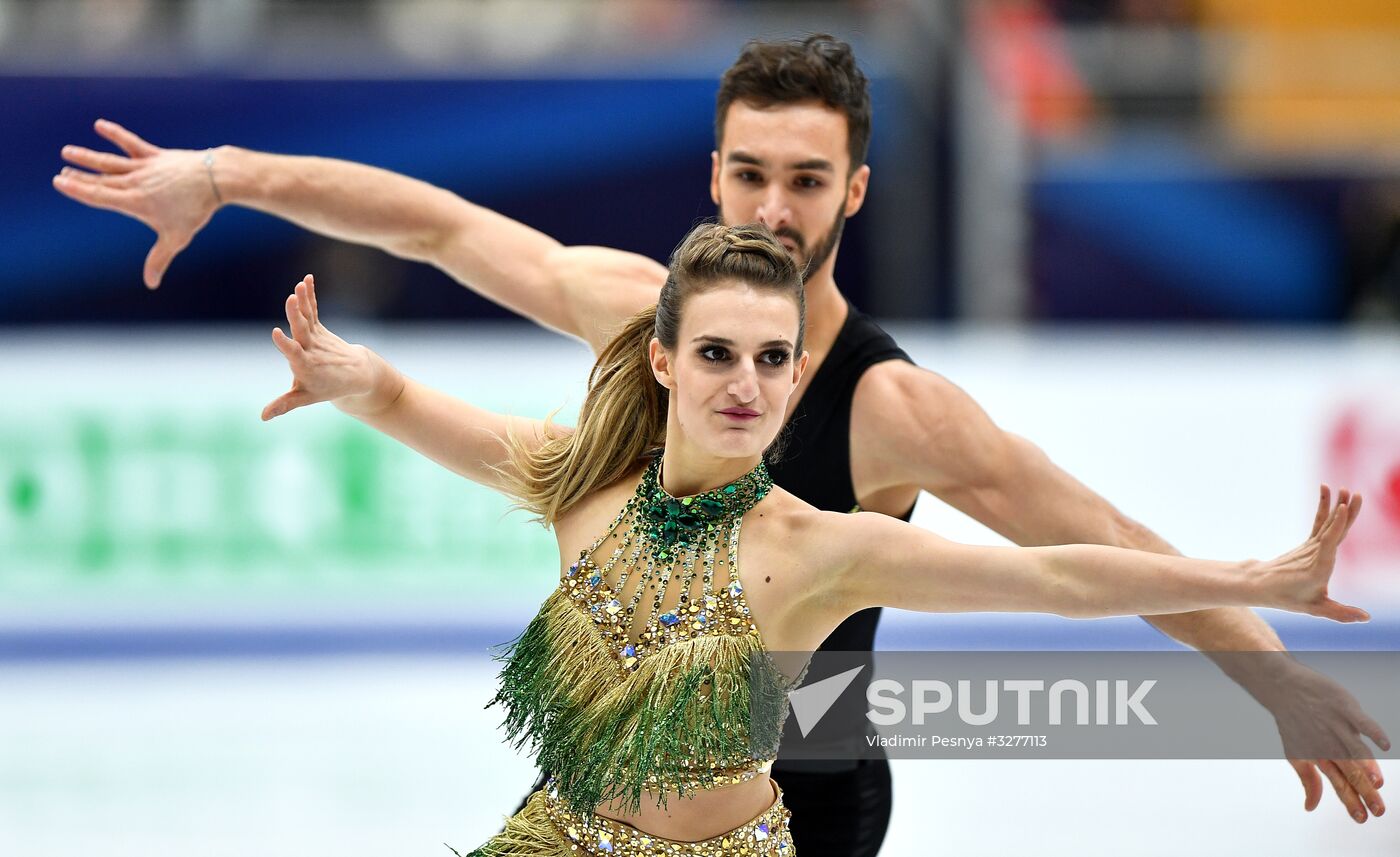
<box><xmin>262</xmin><ymin>274</ymin><xmax>382</xmax><ymax>420</ymax></box>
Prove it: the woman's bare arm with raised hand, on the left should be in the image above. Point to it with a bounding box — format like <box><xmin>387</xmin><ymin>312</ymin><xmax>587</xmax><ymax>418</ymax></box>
<box><xmin>262</xmin><ymin>274</ymin><xmax>557</xmax><ymax>487</ymax></box>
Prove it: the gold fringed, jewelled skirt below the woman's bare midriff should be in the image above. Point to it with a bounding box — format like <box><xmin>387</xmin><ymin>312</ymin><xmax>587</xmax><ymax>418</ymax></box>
<box><xmin>468</xmin><ymin>783</ymin><xmax>797</xmax><ymax>857</ymax></box>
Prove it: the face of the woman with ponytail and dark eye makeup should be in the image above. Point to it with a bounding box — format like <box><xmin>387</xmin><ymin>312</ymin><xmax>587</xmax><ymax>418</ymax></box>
<box><xmin>651</xmin><ymin>283</ymin><xmax>806</xmax><ymax>458</ymax></box>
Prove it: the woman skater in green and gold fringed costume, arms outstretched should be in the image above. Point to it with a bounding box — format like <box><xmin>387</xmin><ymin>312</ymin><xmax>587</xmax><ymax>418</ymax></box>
<box><xmin>263</xmin><ymin>224</ymin><xmax>1368</xmax><ymax>857</ymax></box>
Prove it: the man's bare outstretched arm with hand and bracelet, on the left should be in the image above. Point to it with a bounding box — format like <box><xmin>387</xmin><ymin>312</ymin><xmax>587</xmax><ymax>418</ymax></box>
<box><xmin>55</xmin><ymin>120</ymin><xmax>666</xmax><ymax>350</ymax></box>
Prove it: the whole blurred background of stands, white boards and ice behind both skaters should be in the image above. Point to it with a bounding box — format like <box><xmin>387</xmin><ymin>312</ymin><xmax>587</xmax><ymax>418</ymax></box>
<box><xmin>0</xmin><ymin>0</ymin><xmax>1400</xmax><ymax>857</ymax></box>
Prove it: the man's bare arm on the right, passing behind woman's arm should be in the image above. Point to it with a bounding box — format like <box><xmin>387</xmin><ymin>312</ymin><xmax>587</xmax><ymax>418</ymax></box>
<box><xmin>851</xmin><ymin>360</ymin><xmax>1389</xmax><ymax>822</ymax></box>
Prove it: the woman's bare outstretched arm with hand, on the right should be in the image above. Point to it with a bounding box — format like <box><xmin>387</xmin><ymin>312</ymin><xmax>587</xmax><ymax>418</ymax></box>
<box><xmin>829</xmin><ymin>490</ymin><xmax>1369</xmax><ymax>622</ymax></box>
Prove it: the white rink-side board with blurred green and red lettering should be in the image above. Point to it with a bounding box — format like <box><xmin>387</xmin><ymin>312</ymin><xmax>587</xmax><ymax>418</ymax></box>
<box><xmin>0</xmin><ymin>325</ymin><xmax>1400</xmax><ymax>646</ymax></box>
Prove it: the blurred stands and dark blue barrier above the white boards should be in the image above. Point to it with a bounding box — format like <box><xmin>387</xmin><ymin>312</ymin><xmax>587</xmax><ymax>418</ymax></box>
<box><xmin>0</xmin><ymin>0</ymin><xmax>1400</xmax><ymax>325</ymax></box>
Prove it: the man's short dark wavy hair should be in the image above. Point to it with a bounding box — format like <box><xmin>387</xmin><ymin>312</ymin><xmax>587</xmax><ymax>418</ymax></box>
<box><xmin>714</xmin><ymin>34</ymin><xmax>871</xmax><ymax>171</ymax></box>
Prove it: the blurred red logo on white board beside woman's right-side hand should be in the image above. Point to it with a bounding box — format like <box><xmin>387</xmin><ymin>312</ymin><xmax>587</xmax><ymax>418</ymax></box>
<box><xmin>1323</xmin><ymin>400</ymin><xmax>1400</xmax><ymax>573</ymax></box>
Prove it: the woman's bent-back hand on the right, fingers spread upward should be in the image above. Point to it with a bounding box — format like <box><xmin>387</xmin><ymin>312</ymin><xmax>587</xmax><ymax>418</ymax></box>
<box><xmin>1261</xmin><ymin>485</ymin><xmax>1371</xmax><ymax>622</ymax></box>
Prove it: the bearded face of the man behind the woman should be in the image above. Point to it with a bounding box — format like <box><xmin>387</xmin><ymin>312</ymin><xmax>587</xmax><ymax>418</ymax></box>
<box><xmin>710</xmin><ymin>101</ymin><xmax>869</xmax><ymax>277</ymax></box>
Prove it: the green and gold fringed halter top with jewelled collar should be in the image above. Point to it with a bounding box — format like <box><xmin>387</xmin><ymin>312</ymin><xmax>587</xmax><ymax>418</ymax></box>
<box><xmin>473</xmin><ymin>455</ymin><xmax>791</xmax><ymax>857</ymax></box>
